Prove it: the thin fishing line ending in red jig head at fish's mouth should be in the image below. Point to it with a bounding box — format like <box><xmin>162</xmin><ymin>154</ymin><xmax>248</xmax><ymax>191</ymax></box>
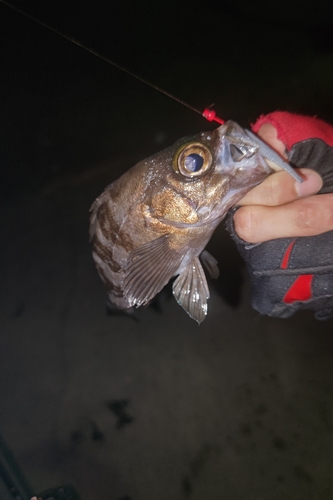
<box><xmin>0</xmin><ymin>0</ymin><xmax>224</xmax><ymax>125</ymax></box>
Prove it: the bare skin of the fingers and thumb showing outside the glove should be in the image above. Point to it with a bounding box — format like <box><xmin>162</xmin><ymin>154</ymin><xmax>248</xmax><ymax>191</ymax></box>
<box><xmin>234</xmin><ymin>123</ymin><xmax>333</xmax><ymax>243</ymax></box>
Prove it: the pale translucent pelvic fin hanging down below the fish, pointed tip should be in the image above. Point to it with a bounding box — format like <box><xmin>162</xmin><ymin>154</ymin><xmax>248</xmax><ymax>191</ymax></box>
<box><xmin>172</xmin><ymin>257</ymin><xmax>209</xmax><ymax>324</ymax></box>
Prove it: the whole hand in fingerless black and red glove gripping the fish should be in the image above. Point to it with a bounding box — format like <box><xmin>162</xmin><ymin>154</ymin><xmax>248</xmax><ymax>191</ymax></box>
<box><xmin>227</xmin><ymin>112</ymin><xmax>333</xmax><ymax>319</ymax></box>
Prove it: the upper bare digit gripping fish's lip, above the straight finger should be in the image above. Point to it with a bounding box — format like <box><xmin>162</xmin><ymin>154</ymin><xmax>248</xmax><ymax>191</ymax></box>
<box><xmin>237</xmin><ymin>168</ymin><xmax>323</xmax><ymax>206</ymax></box>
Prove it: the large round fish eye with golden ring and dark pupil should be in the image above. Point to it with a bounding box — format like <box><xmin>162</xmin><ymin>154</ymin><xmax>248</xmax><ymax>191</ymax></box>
<box><xmin>173</xmin><ymin>142</ymin><xmax>213</xmax><ymax>178</ymax></box>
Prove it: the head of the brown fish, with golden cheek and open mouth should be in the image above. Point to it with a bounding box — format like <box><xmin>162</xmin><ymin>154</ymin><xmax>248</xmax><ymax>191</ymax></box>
<box><xmin>146</xmin><ymin>121</ymin><xmax>272</xmax><ymax>227</ymax></box>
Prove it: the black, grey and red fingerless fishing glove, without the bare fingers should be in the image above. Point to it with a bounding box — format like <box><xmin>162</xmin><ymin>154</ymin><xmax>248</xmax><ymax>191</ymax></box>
<box><xmin>227</xmin><ymin>111</ymin><xmax>333</xmax><ymax>320</ymax></box>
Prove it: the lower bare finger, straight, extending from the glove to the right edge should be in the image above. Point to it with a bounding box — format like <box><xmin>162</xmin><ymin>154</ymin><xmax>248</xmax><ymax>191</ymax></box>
<box><xmin>234</xmin><ymin>193</ymin><xmax>333</xmax><ymax>243</ymax></box>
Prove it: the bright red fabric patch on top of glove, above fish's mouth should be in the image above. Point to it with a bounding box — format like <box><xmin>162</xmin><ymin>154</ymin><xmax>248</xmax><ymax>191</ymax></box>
<box><xmin>251</xmin><ymin>111</ymin><xmax>333</xmax><ymax>151</ymax></box>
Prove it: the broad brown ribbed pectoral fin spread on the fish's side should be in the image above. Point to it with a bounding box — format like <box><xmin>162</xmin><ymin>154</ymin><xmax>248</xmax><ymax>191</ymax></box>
<box><xmin>122</xmin><ymin>235</ymin><xmax>184</xmax><ymax>307</ymax></box>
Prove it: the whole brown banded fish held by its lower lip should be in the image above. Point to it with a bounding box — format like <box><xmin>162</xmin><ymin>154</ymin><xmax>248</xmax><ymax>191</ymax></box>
<box><xmin>90</xmin><ymin>121</ymin><xmax>274</xmax><ymax>324</ymax></box>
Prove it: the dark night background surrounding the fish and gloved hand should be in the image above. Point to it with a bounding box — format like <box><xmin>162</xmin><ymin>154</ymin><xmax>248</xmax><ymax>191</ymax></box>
<box><xmin>0</xmin><ymin>0</ymin><xmax>333</xmax><ymax>500</ymax></box>
